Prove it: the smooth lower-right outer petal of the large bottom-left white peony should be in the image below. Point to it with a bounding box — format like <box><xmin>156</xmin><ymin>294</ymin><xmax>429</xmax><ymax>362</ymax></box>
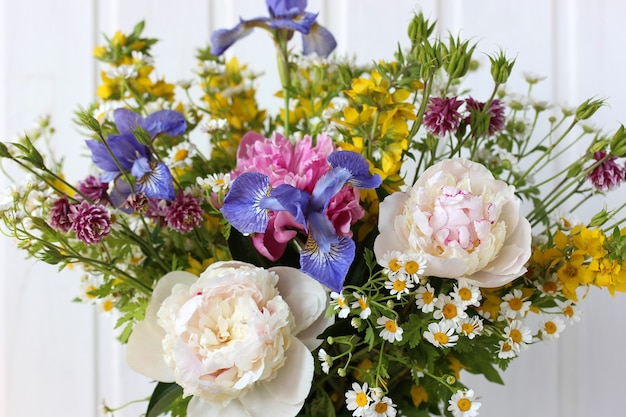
<box><xmin>241</xmin><ymin>337</ymin><xmax>314</xmax><ymax>417</ymax></box>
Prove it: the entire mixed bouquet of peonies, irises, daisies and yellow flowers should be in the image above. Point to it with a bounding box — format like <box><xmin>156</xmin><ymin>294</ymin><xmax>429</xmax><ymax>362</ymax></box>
<box><xmin>0</xmin><ymin>0</ymin><xmax>626</xmax><ymax>417</ymax></box>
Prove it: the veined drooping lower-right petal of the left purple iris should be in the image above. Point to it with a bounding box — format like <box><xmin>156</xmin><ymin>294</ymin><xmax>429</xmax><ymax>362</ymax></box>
<box><xmin>131</xmin><ymin>158</ymin><xmax>175</xmax><ymax>200</ymax></box>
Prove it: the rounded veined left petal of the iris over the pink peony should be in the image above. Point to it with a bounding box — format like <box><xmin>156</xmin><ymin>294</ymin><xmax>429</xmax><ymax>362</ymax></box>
<box><xmin>221</xmin><ymin>172</ymin><xmax>271</xmax><ymax>235</ymax></box>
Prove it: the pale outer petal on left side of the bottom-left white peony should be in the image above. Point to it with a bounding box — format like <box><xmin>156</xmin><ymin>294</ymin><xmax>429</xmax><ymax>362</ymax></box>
<box><xmin>126</xmin><ymin>271</ymin><xmax>198</xmax><ymax>382</ymax></box>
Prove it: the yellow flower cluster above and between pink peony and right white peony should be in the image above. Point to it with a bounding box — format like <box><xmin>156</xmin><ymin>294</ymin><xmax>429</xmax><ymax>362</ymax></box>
<box><xmin>336</xmin><ymin>63</ymin><xmax>421</xmax><ymax>192</ymax></box>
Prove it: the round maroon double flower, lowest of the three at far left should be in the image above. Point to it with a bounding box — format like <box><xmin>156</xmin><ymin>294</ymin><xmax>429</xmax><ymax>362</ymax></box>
<box><xmin>68</xmin><ymin>201</ymin><xmax>111</xmax><ymax>245</ymax></box>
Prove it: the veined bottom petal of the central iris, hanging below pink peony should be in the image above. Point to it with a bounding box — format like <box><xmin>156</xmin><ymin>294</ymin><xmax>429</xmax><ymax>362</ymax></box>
<box><xmin>300</xmin><ymin>236</ymin><xmax>356</xmax><ymax>292</ymax></box>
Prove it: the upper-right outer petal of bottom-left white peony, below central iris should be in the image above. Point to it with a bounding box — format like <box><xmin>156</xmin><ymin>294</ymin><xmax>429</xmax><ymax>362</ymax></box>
<box><xmin>270</xmin><ymin>266</ymin><xmax>328</xmax><ymax>336</ymax></box>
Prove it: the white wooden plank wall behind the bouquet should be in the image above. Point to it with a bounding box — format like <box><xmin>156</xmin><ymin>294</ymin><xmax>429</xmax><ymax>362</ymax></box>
<box><xmin>0</xmin><ymin>0</ymin><xmax>626</xmax><ymax>417</ymax></box>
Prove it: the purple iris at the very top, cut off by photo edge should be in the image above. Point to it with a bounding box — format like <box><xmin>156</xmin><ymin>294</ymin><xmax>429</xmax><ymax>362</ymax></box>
<box><xmin>211</xmin><ymin>0</ymin><xmax>337</xmax><ymax>57</ymax></box>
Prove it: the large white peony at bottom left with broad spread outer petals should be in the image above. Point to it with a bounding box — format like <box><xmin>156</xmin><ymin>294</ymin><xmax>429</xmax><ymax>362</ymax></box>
<box><xmin>127</xmin><ymin>262</ymin><xmax>330</xmax><ymax>417</ymax></box>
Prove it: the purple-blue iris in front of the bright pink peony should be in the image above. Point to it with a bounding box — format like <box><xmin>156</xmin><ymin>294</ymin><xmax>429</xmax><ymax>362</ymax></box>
<box><xmin>221</xmin><ymin>151</ymin><xmax>382</xmax><ymax>292</ymax></box>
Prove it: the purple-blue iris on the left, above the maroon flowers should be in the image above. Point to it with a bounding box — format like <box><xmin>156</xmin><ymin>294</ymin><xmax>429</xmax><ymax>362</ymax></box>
<box><xmin>86</xmin><ymin>108</ymin><xmax>187</xmax><ymax>207</ymax></box>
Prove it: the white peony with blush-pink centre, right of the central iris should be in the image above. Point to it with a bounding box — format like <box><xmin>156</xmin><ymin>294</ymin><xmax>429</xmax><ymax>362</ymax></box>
<box><xmin>374</xmin><ymin>158</ymin><xmax>532</xmax><ymax>287</ymax></box>
